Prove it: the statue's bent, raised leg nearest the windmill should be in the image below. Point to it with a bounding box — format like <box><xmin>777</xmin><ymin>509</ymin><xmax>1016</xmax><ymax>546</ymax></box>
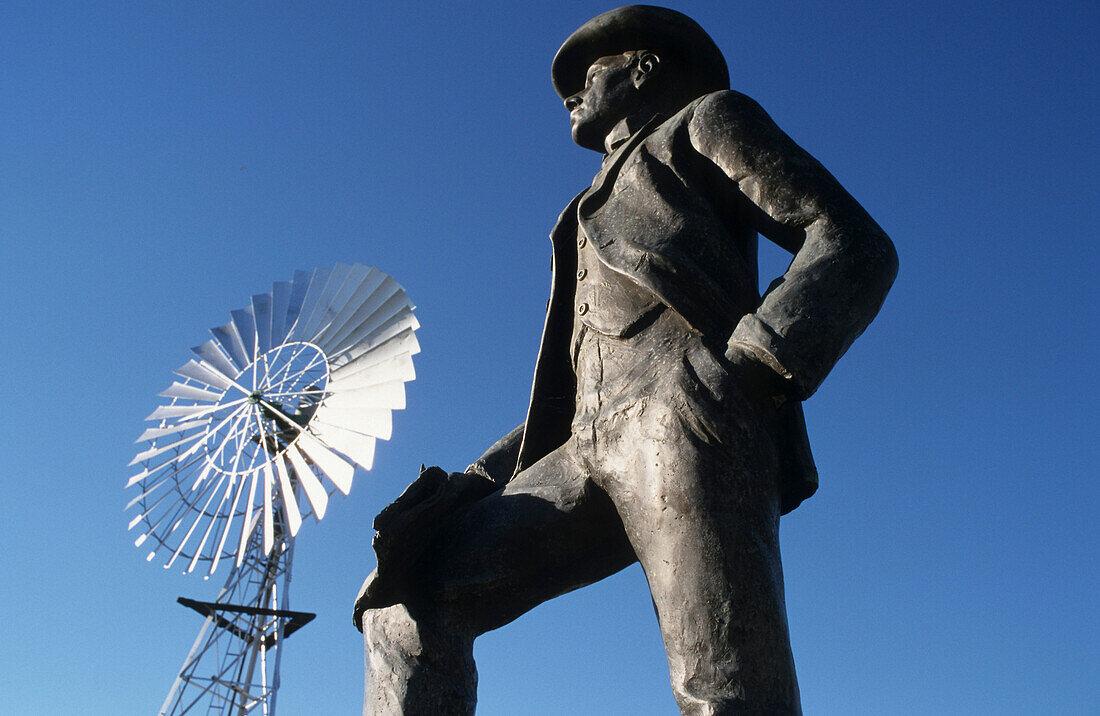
<box><xmin>363</xmin><ymin>443</ymin><xmax>635</xmax><ymax>716</ymax></box>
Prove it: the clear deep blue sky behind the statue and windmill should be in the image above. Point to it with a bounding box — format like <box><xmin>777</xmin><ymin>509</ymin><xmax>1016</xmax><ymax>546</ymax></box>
<box><xmin>0</xmin><ymin>0</ymin><xmax>1100</xmax><ymax>716</ymax></box>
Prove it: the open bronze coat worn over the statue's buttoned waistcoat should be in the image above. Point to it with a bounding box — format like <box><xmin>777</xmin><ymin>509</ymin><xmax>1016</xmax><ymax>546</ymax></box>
<box><xmin>471</xmin><ymin>91</ymin><xmax>898</xmax><ymax>513</ymax></box>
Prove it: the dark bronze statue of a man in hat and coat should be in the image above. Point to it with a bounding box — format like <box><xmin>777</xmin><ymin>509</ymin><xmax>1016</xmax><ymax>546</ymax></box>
<box><xmin>355</xmin><ymin>5</ymin><xmax>898</xmax><ymax>716</ymax></box>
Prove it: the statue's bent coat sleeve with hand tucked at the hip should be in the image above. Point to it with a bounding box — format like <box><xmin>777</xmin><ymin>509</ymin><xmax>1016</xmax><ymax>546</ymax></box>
<box><xmin>689</xmin><ymin>91</ymin><xmax>898</xmax><ymax>399</ymax></box>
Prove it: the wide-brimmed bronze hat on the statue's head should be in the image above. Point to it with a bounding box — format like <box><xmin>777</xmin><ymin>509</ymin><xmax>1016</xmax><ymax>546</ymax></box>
<box><xmin>550</xmin><ymin>5</ymin><xmax>729</xmax><ymax>99</ymax></box>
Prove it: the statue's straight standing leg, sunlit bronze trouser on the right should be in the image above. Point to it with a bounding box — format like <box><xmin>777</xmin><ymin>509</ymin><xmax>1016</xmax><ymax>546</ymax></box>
<box><xmin>596</xmin><ymin>365</ymin><xmax>800</xmax><ymax>715</ymax></box>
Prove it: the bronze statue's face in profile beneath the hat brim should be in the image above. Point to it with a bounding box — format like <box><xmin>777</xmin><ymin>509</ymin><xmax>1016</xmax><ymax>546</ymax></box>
<box><xmin>565</xmin><ymin>53</ymin><xmax>639</xmax><ymax>152</ymax></box>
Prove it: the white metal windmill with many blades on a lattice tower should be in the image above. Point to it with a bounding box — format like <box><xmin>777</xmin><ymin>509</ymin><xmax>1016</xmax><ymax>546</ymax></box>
<box><xmin>127</xmin><ymin>264</ymin><xmax>419</xmax><ymax>716</ymax></box>
